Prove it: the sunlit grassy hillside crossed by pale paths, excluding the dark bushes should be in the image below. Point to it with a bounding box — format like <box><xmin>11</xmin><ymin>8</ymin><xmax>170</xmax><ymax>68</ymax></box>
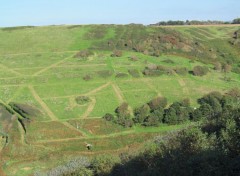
<box><xmin>0</xmin><ymin>25</ymin><xmax>240</xmax><ymax>175</ymax></box>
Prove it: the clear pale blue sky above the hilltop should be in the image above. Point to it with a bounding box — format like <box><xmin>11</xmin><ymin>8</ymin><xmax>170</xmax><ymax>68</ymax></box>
<box><xmin>0</xmin><ymin>0</ymin><xmax>240</xmax><ymax>27</ymax></box>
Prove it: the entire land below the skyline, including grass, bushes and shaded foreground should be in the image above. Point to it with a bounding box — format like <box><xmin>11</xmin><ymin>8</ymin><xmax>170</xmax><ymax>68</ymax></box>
<box><xmin>0</xmin><ymin>24</ymin><xmax>240</xmax><ymax>176</ymax></box>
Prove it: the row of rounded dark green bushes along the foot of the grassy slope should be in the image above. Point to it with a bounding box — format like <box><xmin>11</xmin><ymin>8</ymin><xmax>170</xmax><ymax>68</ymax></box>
<box><xmin>103</xmin><ymin>89</ymin><xmax>240</xmax><ymax>128</ymax></box>
